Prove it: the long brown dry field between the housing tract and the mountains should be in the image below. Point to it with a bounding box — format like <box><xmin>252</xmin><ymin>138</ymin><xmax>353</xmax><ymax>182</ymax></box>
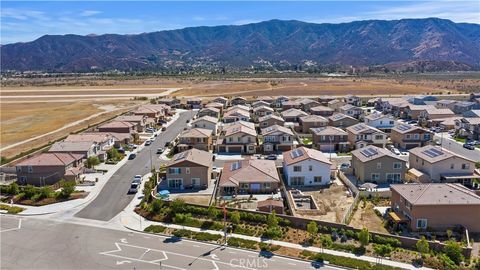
<box><xmin>175</xmin><ymin>78</ymin><xmax>464</xmax><ymax>96</ymax></box>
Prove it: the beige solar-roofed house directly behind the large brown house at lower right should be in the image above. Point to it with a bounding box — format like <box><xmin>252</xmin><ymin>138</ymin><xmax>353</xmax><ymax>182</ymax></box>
<box><xmin>409</xmin><ymin>145</ymin><xmax>480</xmax><ymax>186</ymax></box>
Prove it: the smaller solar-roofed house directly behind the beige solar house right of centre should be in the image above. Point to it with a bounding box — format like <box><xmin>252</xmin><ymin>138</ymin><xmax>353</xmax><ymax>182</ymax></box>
<box><xmin>347</xmin><ymin>123</ymin><xmax>387</xmax><ymax>149</ymax></box>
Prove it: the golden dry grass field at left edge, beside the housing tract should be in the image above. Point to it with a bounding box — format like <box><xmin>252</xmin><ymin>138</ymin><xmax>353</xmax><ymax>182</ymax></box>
<box><xmin>0</xmin><ymin>101</ymin><xmax>140</xmax><ymax>157</ymax></box>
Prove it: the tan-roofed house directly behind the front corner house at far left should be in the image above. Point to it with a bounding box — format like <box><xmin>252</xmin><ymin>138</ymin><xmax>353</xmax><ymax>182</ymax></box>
<box><xmin>48</xmin><ymin>141</ymin><xmax>107</xmax><ymax>161</ymax></box>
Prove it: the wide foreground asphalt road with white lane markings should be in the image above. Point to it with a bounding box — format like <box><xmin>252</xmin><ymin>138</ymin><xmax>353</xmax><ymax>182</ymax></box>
<box><xmin>0</xmin><ymin>216</ymin><xmax>338</xmax><ymax>270</ymax></box>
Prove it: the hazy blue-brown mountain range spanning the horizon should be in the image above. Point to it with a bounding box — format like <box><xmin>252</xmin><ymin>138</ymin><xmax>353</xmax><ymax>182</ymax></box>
<box><xmin>0</xmin><ymin>18</ymin><xmax>480</xmax><ymax>72</ymax></box>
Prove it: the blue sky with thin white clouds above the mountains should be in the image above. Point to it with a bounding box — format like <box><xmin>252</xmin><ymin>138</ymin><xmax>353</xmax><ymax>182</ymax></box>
<box><xmin>0</xmin><ymin>0</ymin><xmax>480</xmax><ymax>44</ymax></box>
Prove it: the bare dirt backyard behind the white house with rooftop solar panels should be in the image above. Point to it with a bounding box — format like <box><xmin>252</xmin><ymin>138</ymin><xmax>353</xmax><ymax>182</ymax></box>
<box><xmin>297</xmin><ymin>181</ymin><xmax>353</xmax><ymax>222</ymax></box>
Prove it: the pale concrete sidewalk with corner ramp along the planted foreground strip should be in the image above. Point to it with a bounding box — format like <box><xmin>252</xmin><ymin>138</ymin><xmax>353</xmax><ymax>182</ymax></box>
<box><xmin>119</xmin><ymin>199</ymin><xmax>430</xmax><ymax>269</ymax></box>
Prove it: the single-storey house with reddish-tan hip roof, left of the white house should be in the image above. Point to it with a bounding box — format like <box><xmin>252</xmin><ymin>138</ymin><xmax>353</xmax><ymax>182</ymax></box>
<box><xmin>218</xmin><ymin>159</ymin><xmax>280</xmax><ymax>195</ymax></box>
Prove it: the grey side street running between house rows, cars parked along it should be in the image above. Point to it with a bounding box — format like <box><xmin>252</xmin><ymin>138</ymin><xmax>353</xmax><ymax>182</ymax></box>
<box><xmin>75</xmin><ymin>111</ymin><xmax>195</xmax><ymax>221</ymax></box>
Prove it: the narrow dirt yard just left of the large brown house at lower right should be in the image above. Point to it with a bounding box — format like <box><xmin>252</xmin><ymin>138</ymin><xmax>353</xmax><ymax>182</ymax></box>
<box><xmin>350</xmin><ymin>201</ymin><xmax>388</xmax><ymax>233</ymax></box>
